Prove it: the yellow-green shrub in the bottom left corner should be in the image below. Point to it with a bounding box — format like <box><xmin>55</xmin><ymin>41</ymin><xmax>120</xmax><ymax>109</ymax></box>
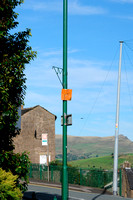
<box><xmin>0</xmin><ymin>168</ymin><xmax>23</xmax><ymax>200</ymax></box>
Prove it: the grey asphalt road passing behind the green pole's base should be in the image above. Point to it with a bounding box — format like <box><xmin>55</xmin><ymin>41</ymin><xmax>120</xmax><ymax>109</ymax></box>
<box><xmin>24</xmin><ymin>184</ymin><xmax>131</xmax><ymax>200</ymax></box>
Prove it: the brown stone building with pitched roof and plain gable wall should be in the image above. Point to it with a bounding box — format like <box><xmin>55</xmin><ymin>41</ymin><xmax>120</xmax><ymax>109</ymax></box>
<box><xmin>14</xmin><ymin>105</ymin><xmax>56</xmax><ymax>164</ymax></box>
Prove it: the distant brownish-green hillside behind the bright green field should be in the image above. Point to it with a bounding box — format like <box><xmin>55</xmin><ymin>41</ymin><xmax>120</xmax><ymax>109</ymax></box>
<box><xmin>56</xmin><ymin>135</ymin><xmax>133</xmax><ymax>161</ymax></box>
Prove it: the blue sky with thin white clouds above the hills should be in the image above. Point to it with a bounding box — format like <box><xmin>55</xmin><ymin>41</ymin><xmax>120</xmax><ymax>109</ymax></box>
<box><xmin>16</xmin><ymin>0</ymin><xmax>133</xmax><ymax>141</ymax></box>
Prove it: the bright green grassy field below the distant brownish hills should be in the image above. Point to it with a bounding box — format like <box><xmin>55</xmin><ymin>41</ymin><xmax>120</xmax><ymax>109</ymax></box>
<box><xmin>68</xmin><ymin>154</ymin><xmax>133</xmax><ymax>169</ymax></box>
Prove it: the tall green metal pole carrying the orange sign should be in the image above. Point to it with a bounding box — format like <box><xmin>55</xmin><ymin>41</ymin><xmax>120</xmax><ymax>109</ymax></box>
<box><xmin>62</xmin><ymin>0</ymin><xmax>68</xmax><ymax>200</ymax></box>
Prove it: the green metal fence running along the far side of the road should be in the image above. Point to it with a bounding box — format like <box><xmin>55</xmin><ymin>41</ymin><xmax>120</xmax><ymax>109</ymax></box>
<box><xmin>29</xmin><ymin>164</ymin><xmax>117</xmax><ymax>188</ymax></box>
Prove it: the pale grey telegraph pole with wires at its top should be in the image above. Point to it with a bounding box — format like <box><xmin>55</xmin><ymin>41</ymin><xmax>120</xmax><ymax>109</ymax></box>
<box><xmin>113</xmin><ymin>41</ymin><xmax>123</xmax><ymax>195</ymax></box>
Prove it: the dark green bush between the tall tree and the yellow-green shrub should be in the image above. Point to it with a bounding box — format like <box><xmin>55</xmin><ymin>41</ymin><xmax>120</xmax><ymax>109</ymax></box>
<box><xmin>0</xmin><ymin>151</ymin><xmax>30</xmax><ymax>192</ymax></box>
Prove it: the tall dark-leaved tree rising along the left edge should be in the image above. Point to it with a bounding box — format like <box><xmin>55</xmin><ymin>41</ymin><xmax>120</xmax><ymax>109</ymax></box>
<box><xmin>0</xmin><ymin>0</ymin><xmax>36</xmax><ymax>152</ymax></box>
